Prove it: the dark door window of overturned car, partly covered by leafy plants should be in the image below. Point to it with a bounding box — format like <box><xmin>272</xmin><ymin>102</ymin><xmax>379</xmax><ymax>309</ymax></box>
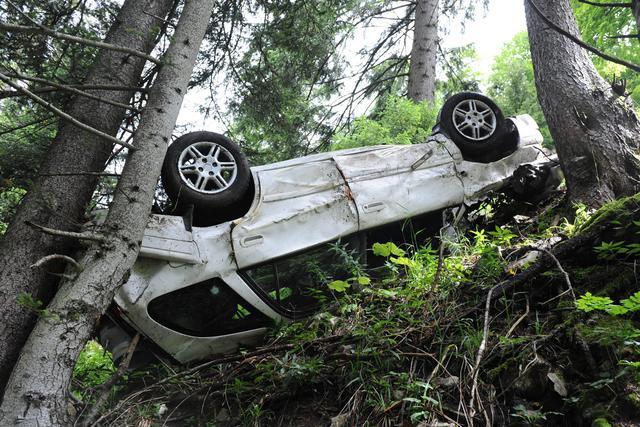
<box><xmin>243</xmin><ymin>236</ymin><xmax>360</xmax><ymax>318</ymax></box>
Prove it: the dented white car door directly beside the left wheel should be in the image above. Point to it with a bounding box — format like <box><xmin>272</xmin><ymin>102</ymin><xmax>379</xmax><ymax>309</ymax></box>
<box><xmin>231</xmin><ymin>155</ymin><xmax>358</xmax><ymax>269</ymax></box>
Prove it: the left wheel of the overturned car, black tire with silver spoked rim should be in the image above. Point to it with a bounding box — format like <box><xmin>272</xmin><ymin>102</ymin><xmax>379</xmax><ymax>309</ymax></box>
<box><xmin>162</xmin><ymin>132</ymin><xmax>251</xmax><ymax>211</ymax></box>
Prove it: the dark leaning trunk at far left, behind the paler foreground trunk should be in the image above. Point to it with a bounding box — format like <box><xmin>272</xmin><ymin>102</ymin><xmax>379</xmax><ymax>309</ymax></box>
<box><xmin>0</xmin><ymin>0</ymin><xmax>174</xmax><ymax>393</ymax></box>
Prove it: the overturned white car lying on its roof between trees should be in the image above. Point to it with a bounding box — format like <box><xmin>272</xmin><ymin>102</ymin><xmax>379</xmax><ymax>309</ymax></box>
<box><xmin>101</xmin><ymin>93</ymin><xmax>545</xmax><ymax>362</ymax></box>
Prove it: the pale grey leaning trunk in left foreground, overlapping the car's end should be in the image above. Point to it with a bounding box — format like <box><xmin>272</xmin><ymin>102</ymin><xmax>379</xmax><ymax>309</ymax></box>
<box><xmin>0</xmin><ymin>0</ymin><xmax>214</xmax><ymax>426</ymax></box>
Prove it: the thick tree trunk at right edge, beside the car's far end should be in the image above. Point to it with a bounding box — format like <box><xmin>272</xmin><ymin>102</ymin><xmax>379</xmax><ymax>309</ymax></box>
<box><xmin>525</xmin><ymin>0</ymin><xmax>640</xmax><ymax>206</ymax></box>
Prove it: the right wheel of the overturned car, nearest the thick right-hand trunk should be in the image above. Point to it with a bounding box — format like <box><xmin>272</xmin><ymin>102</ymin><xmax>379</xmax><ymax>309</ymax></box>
<box><xmin>438</xmin><ymin>92</ymin><xmax>519</xmax><ymax>162</ymax></box>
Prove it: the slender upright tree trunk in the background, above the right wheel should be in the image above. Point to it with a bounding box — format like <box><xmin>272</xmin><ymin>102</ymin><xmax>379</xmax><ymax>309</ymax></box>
<box><xmin>409</xmin><ymin>0</ymin><xmax>439</xmax><ymax>102</ymax></box>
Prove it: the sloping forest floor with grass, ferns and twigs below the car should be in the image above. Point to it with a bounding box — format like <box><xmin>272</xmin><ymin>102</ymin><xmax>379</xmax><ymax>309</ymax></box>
<box><xmin>79</xmin><ymin>192</ymin><xmax>640</xmax><ymax>427</ymax></box>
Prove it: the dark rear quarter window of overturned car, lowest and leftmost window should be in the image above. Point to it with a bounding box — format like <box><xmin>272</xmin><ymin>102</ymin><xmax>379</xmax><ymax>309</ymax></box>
<box><xmin>147</xmin><ymin>278</ymin><xmax>271</xmax><ymax>337</ymax></box>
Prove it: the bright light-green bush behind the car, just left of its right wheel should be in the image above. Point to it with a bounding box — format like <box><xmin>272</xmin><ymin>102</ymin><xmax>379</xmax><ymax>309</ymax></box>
<box><xmin>331</xmin><ymin>97</ymin><xmax>438</xmax><ymax>150</ymax></box>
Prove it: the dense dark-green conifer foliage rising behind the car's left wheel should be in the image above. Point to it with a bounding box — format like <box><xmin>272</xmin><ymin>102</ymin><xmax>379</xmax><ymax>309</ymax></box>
<box><xmin>230</xmin><ymin>0</ymin><xmax>357</xmax><ymax>164</ymax></box>
